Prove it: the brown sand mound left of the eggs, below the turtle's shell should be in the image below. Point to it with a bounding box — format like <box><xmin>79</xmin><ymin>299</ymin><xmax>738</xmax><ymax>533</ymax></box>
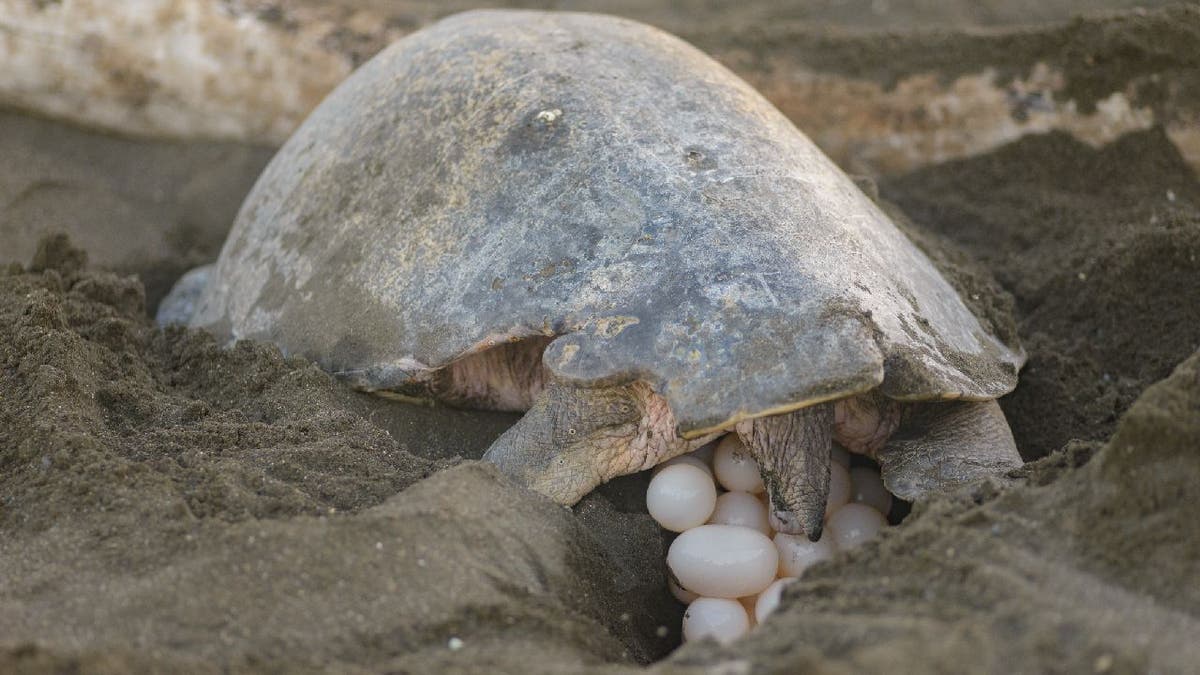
<box><xmin>0</xmin><ymin>238</ymin><xmax>677</xmax><ymax>670</ymax></box>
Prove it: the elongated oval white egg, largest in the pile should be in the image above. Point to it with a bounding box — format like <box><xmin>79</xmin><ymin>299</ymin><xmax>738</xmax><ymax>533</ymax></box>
<box><xmin>667</xmin><ymin>525</ymin><xmax>779</xmax><ymax>598</ymax></box>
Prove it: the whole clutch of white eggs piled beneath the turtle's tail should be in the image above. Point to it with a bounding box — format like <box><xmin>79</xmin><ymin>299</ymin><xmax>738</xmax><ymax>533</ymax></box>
<box><xmin>646</xmin><ymin>434</ymin><xmax>892</xmax><ymax>643</ymax></box>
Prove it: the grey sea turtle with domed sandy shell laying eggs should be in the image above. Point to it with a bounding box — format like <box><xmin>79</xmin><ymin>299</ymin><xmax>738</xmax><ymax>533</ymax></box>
<box><xmin>174</xmin><ymin>11</ymin><xmax>1024</xmax><ymax>538</ymax></box>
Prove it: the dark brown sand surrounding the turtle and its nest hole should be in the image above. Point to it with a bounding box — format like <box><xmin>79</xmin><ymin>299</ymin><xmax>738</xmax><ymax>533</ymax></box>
<box><xmin>0</xmin><ymin>2</ymin><xmax>1200</xmax><ymax>673</ymax></box>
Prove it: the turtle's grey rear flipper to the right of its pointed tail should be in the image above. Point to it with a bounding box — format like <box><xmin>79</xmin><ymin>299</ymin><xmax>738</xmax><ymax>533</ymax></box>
<box><xmin>876</xmin><ymin>400</ymin><xmax>1021</xmax><ymax>501</ymax></box>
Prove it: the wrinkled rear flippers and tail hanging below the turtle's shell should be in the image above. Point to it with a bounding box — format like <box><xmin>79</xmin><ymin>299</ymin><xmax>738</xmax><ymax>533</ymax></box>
<box><xmin>484</xmin><ymin>383</ymin><xmax>1021</xmax><ymax>540</ymax></box>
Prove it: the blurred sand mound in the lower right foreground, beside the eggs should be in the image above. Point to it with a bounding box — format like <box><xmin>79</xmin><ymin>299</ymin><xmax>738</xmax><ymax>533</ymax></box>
<box><xmin>662</xmin><ymin>354</ymin><xmax>1200</xmax><ymax>673</ymax></box>
